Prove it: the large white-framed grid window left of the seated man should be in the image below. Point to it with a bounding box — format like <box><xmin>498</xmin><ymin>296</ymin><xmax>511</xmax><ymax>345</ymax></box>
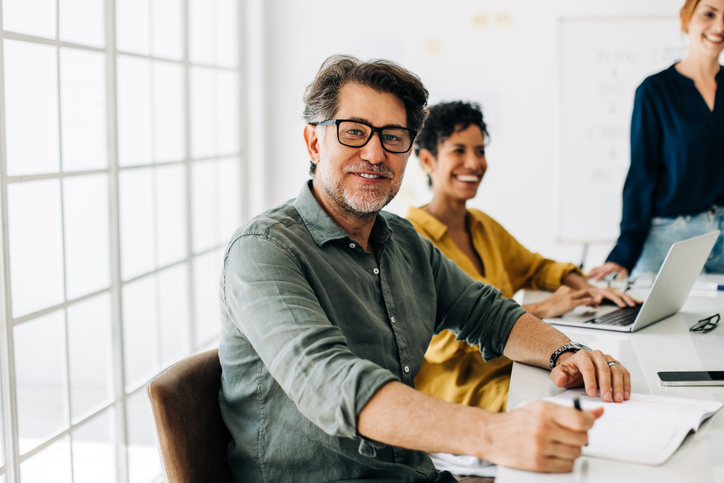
<box><xmin>0</xmin><ymin>0</ymin><xmax>243</xmax><ymax>483</ymax></box>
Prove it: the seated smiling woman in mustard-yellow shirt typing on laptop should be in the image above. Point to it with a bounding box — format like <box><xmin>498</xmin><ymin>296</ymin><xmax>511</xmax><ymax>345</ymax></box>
<box><xmin>407</xmin><ymin>102</ymin><xmax>635</xmax><ymax>411</ymax></box>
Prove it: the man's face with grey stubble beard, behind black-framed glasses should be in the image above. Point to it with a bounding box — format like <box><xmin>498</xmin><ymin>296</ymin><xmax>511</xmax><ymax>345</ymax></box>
<box><xmin>310</xmin><ymin>84</ymin><xmax>410</xmax><ymax>218</ymax></box>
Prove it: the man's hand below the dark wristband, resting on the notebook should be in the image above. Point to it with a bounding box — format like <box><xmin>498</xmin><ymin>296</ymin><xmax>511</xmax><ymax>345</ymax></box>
<box><xmin>551</xmin><ymin>350</ymin><xmax>631</xmax><ymax>402</ymax></box>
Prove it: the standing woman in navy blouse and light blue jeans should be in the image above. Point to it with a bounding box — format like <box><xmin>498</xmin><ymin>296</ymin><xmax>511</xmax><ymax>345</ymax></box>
<box><xmin>588</xmin><ymin>0</ymin><xmax>724</xmax><ymax>279</ymax></box>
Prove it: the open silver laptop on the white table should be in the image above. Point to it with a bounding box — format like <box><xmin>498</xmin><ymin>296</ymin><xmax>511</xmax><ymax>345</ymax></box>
<box><xmin>545</xmin><ymin>230</ymin><xmax>719</xmax><ymax>332</ymax></box>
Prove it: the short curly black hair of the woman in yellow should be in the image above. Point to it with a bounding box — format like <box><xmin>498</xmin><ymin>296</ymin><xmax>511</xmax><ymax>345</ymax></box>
<box><xmin>415</xmin><ymin>101</ymin><xmax>488</xmax><ymax>156</ymax></box>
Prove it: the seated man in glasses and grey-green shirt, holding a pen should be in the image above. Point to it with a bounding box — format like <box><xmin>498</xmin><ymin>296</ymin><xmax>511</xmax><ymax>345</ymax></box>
<box><xmin>219</xmin><ymin>56</ymin><xmax>630</xmax><ymax>482</ymax></box>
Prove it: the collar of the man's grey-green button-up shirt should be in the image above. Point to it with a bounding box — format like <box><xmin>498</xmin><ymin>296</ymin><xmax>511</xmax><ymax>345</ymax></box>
<box><xmin>294</xmin><ymin>180</ymin><xmax>391</xmax><ymax>247</ymax></box>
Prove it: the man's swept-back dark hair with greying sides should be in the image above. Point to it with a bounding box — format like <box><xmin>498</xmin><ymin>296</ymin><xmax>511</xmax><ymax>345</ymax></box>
<box><xmin>302</xmin><ymin>55</ymin><xmax>428</xmax><ymax>176</ymax></box>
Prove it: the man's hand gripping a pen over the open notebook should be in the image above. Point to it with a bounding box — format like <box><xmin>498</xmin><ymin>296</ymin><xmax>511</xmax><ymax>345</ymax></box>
<box><xmin>483</xmin><ymin>401</ymin><xmax>603</xmax><ymax>473</ymax></box>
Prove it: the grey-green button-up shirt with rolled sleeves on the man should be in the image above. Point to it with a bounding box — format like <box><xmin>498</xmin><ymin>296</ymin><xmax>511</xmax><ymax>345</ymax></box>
<box><xmin>219</xmin><ymin>183</ymin><xmax>524</xmax><ymax>482</ymax></box>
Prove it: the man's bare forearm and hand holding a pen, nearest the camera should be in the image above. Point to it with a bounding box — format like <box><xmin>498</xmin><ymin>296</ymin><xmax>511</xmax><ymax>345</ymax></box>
<box><xmin>357</xmin><ymin>382</ymin><xmax>603</xmax><ymax>472</ymax></box>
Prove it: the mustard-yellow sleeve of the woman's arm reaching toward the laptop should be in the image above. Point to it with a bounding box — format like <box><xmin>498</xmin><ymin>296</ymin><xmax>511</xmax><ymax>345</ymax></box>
<box><xmin>490</xmin><ymin>218</ymin><xmax>583</xmax><ymax>291</ymax></box>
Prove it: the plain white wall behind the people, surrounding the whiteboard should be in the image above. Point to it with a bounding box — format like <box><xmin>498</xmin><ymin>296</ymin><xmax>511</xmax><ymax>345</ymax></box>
<box><xmin>258</xmin><ymin>0</ymin><xmax>683</xmax><ymax>267</ymax></box>
